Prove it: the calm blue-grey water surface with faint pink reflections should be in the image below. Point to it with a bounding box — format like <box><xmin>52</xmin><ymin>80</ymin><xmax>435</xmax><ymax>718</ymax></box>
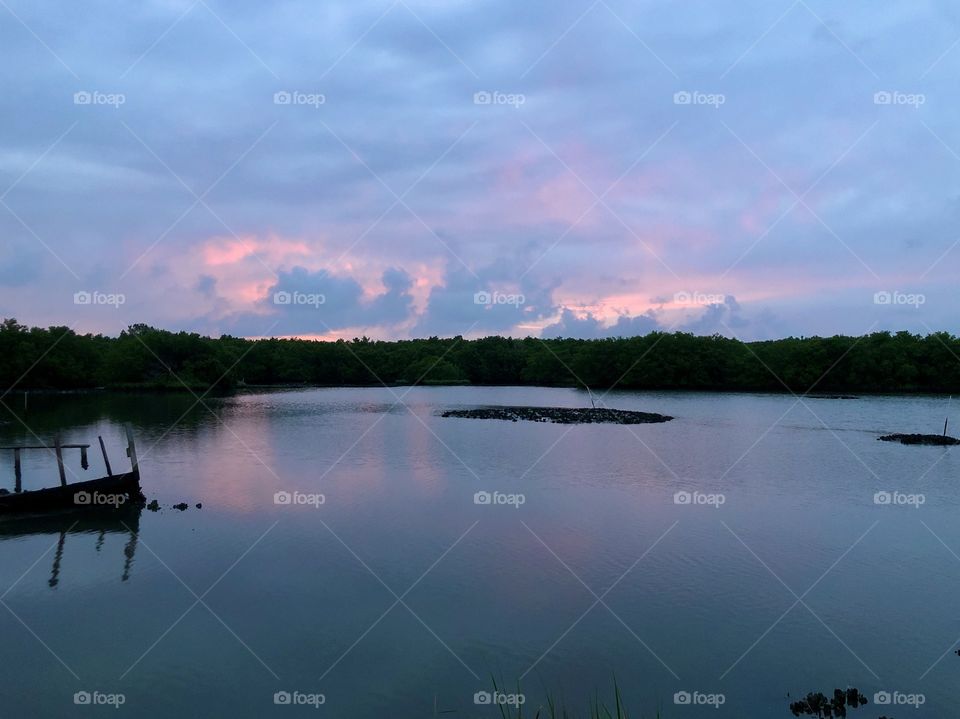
<box><xmin>0</xmin><ymin>387</ymin><xmax>960</xmax><ymax>718</ymax></box>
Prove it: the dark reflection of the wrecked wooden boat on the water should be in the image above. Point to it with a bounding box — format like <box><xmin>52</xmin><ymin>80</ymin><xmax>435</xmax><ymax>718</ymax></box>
<box><xmin>0</xmin><ymin>505</ymin><xmax>143</xmax><ymax>589</ymax></box>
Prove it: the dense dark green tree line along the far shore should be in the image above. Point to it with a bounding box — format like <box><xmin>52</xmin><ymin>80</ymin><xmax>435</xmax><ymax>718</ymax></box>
<box><xmin>0</xmin><ymin>319</ymin><xmax>960</xmax><ymax>394</ymax></box>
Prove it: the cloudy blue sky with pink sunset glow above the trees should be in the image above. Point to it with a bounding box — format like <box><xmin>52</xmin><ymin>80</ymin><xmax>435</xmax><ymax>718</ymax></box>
<box><xmin>0</xmin><ymin>0</ymin><xmax>960</xmax><ymax>340</ymax></box>
